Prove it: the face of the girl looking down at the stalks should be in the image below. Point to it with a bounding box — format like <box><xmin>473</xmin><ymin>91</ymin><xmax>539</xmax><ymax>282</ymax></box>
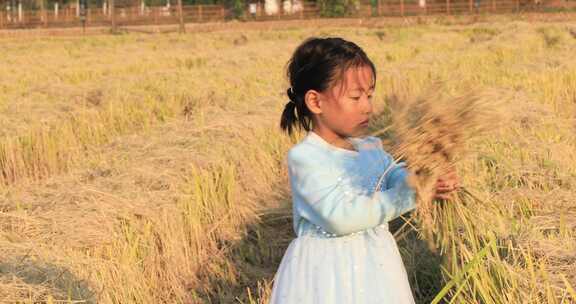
<box><xmin>313</xmin><ymin>66</ymin><xmax>374</xmax><ymax>138</ymax></box>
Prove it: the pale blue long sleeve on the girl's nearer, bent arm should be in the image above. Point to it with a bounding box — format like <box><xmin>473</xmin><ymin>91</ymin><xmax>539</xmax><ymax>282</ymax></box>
<box><xmin>288</xmin><ymin>148</ymin><xmax>414</xmax><ymax>235</ymax></box>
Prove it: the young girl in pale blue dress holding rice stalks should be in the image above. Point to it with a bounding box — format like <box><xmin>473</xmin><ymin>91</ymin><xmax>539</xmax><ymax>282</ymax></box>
<box><xmin>271</xmin><ymin>38</ymin><xmax>456</xmax><ymax>304</ymax></box>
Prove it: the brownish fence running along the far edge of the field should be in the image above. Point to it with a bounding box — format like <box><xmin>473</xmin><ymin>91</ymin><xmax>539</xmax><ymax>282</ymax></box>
<box><xmin>0</xmin><ymin>0</ymin><xmax>576</xmax><ymax>29</ymax></box>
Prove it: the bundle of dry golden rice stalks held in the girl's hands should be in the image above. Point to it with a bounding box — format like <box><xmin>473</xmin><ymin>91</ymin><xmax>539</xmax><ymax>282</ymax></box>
<box><xmin>376</xmin><ymin>84</ymin><xmax>500</xmax><ymax>249</ymax></box>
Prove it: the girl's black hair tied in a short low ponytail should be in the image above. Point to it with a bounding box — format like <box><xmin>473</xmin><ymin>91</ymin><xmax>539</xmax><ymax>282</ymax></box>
<box><xmin>280</xmin><ymin>38</ymin><xmax>376</xmax><ymax>134</ymax></box>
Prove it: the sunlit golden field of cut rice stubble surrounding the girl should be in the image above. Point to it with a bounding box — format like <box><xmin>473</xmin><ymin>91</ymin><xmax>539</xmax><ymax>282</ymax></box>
<box><xmin>0</xmin><ymin>18</ymin><xmax>576</xmax><ymax>304</ymax></box>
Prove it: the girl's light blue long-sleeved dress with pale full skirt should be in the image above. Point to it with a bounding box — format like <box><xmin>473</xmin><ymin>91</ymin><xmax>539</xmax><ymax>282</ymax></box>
<box><xmin>270</xmin><ymin>132</ymin><xmax>415</xmax><ymax>304</ymax></box>
